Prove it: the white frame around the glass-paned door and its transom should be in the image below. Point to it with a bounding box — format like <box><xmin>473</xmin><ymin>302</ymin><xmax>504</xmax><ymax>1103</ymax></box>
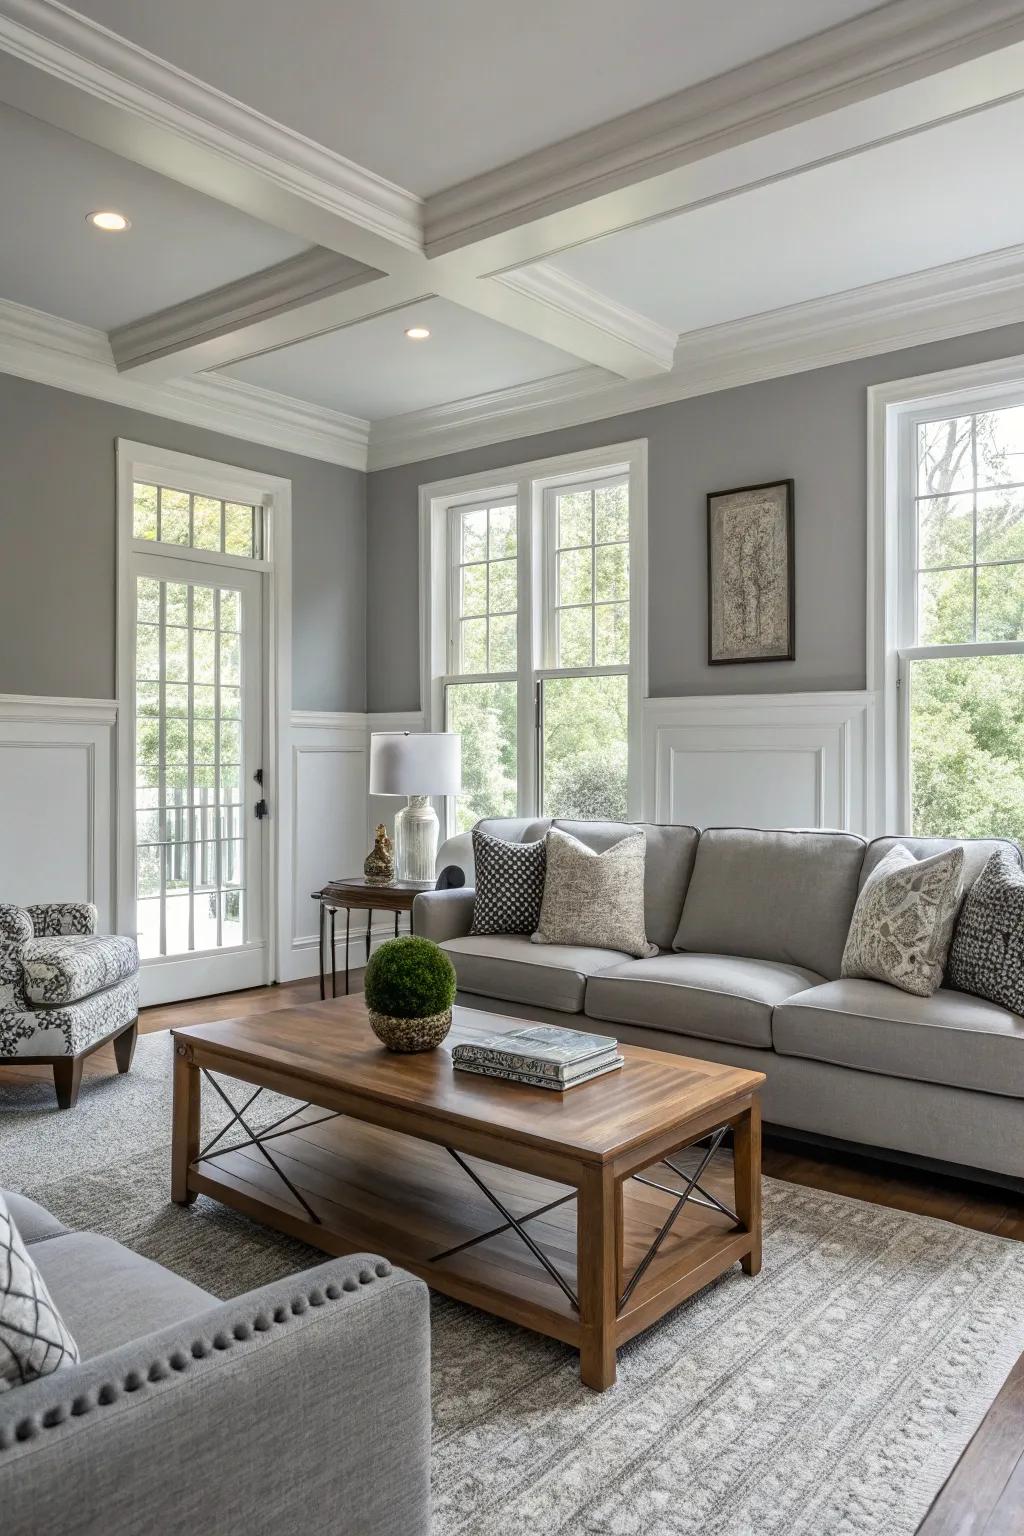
<box><xmin>115</xmin><ymin>438</ymin><xmax>293</xmax><ymax>982</ymax></box>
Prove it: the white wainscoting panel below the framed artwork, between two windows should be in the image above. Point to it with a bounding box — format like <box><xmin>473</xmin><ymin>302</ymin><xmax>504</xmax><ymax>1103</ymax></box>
<box><xmin>642</xmin><ymin>693</ymin><xmax>877</xmax><ymax>836</ymax></box>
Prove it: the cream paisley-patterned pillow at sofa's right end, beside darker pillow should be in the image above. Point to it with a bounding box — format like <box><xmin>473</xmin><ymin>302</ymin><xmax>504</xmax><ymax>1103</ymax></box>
<box><xmin>841</xmin><ymin>843</ymin><xmax>964</xmax><ymax>997</ymax></box>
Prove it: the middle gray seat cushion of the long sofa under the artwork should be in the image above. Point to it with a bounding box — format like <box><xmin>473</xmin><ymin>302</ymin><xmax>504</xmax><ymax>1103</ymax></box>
<box><xmin>585</xmin><ymin>954</ymin><xmax>821</xmax><ymax>1049</ymax></box>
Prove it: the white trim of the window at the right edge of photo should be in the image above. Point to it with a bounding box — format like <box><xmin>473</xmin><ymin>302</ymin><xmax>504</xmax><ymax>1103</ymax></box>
<box><xmin>867</xmin><ymin>356</ymin><xmax>1024</xmax><ymax>834</ymax></box>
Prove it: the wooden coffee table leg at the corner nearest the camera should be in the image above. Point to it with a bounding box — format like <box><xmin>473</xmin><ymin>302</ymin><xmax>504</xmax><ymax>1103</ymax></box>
<box><xmin>576</xmin><ymin>1167</ymin><xmax>622</xmax><ymax>1392</ymax></box>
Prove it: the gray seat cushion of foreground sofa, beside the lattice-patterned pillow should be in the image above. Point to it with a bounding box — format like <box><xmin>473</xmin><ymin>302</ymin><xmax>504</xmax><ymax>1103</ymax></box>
<box><xmin>32</xmin><ymin>1232</ymin><xmax>216</xmax><ymax>1359</ymax></box>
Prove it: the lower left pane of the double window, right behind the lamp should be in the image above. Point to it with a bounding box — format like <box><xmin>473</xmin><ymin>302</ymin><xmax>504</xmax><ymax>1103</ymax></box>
<box><xmin>445</xmin><ymin>682</ymin><xmax>517</xmax><ymax>833</ymax></box>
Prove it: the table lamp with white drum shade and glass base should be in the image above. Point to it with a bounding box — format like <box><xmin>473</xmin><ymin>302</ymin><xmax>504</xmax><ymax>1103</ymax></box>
<box><xmin>370</xmin><ymin>731</ymin><xmax>462</xmax><ymax>885</ymax></box>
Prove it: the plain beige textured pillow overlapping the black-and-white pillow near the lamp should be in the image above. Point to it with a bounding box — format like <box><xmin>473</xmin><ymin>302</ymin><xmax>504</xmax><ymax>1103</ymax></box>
<box><xmin>533</xmin><ymin>826</ymin><xmax>657</xmax><ymax>960</ymax></box>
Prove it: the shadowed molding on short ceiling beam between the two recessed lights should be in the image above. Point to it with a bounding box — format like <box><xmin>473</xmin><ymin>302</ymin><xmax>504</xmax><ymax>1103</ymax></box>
<box><xmin>109</xmin><ymin>246</ymin><xmax>384</xmax><ymax>370</ymax></box>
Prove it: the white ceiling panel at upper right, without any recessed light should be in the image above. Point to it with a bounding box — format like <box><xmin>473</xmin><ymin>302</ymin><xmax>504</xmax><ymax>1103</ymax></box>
<box><xmin>554</xmin><ymin>101</ymin><xmax>1024</xmax><ymax>332</ymax></box>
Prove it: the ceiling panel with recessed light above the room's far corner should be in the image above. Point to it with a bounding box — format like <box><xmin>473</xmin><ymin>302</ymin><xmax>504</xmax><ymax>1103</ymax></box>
<box><xmin>224</xmin><ymin>298</ymin><xmax>580</xmax><ymax>421</ymax></box>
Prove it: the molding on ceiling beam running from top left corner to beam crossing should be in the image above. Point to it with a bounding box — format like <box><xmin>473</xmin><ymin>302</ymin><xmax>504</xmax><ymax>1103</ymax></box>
<box><xmin>0</xmin><ymin>0</ymin><xmax>422</xmax><ymax>253</ymax></box>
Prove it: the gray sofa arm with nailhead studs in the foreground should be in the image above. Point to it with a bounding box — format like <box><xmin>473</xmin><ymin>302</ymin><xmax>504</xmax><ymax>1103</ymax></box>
<box><xmin>0</xmin><ymin>1253</ymin><xmax>430</xmax><ymax>1536</ymax></box>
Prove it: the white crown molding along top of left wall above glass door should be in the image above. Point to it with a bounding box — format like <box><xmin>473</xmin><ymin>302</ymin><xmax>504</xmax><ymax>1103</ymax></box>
<box><xmin>0</xmin><ymin>300</ymin><xmax>370</xmax><ymax>470</ymax></box>
